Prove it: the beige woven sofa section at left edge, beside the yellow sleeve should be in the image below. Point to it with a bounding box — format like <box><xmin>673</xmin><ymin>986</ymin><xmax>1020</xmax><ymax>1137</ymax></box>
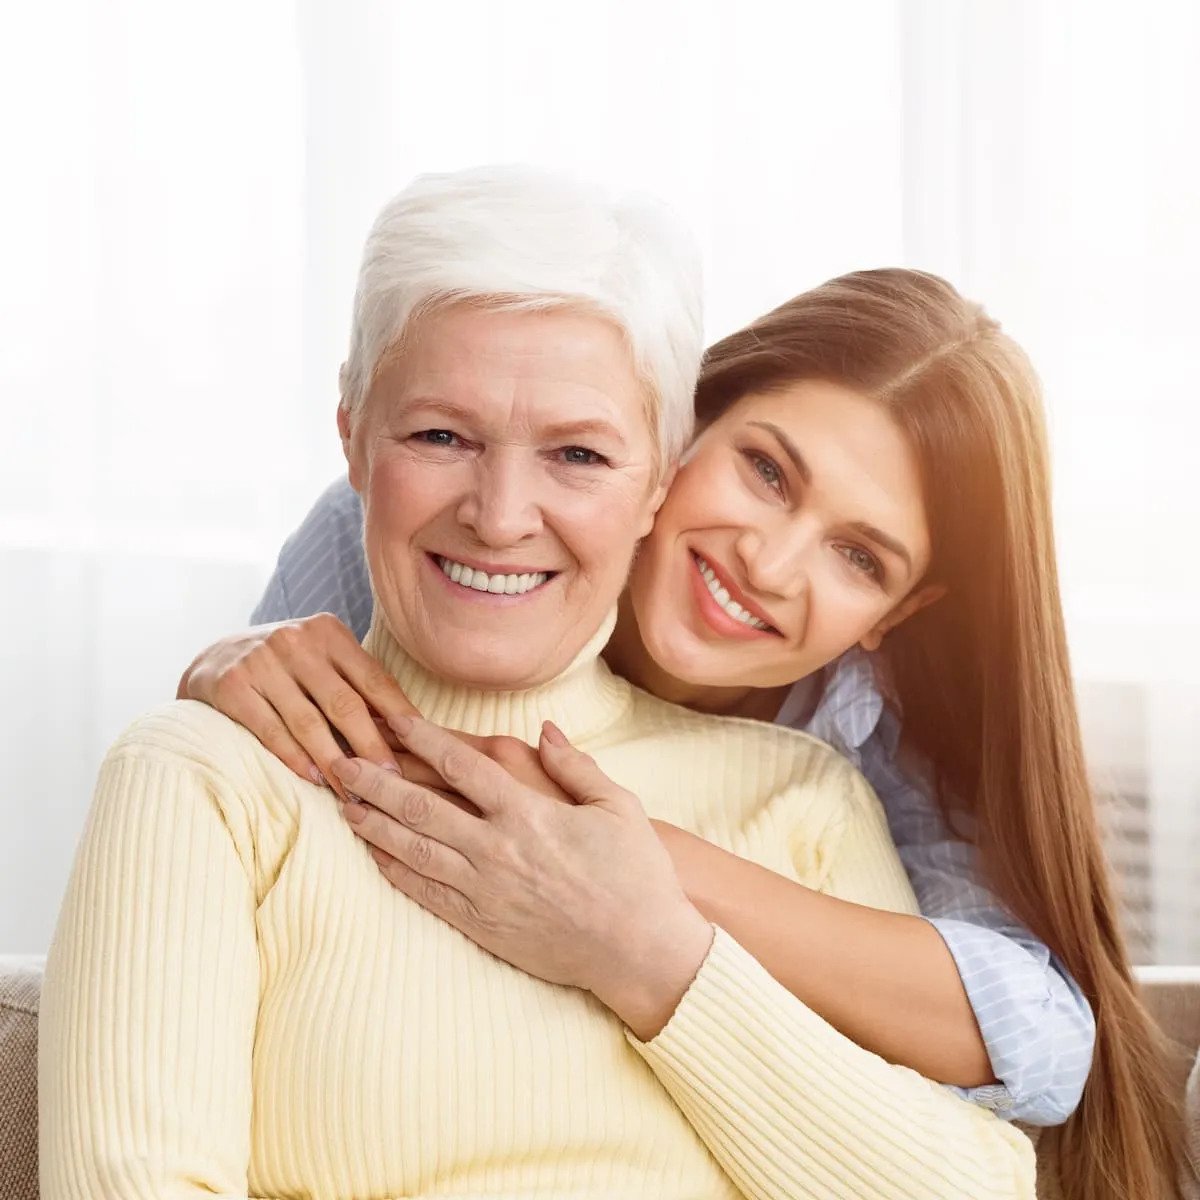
<box><xmin>0</xmin><ymin>959</ymin><xmax>42</xmax><ymax>1200</ymax></box>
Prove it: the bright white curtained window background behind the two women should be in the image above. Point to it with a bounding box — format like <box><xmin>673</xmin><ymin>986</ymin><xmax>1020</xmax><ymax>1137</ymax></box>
<box><xmin>0</xmin><ymin>0</ymin><xmax>1200</xmax><ymax>962</ymax></box>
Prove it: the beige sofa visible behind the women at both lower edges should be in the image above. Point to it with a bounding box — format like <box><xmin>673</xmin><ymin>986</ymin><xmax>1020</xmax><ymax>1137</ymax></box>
<box><xmin>0</xmin><ymin>958</ymin><xmax>1200</xmax><ymax>1200</ymax></box>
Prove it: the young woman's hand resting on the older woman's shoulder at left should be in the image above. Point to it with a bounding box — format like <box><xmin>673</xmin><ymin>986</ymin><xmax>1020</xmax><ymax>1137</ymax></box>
<box><xmin>176</xmin><ymin>612</ymin><xmax>415</xmax><ymax>799</ymax></box>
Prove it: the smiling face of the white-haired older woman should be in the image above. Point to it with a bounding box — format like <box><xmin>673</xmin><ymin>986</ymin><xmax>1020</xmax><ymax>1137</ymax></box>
<box><xmin>338</xmin><ymin>306</ymin><xmax>664</xmax><ymax>689</ymax></box>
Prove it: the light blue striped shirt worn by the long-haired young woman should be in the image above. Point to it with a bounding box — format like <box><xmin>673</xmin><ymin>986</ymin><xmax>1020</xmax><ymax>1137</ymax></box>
<box><xmin>251</xmin><ymin>479</ymin><xmax>1096</xmax><ymax>1124</ymax></box>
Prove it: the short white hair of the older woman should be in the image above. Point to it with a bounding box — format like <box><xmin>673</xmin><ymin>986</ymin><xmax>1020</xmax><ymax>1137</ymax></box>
<box><xmin>341</xmin><ymin>167</ymin><xmax>703</xmax><ymax>466</ymax></box>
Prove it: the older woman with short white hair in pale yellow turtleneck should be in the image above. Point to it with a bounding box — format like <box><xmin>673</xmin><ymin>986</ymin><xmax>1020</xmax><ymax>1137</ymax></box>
<box><xmin>41</xmin><ymin>172</ymin><xmax>1033</xmax><ymax>1200</ymax></box>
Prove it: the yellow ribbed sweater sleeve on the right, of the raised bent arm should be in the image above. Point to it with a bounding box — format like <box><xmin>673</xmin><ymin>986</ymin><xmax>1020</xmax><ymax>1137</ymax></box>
<box><xmin>628</xmin><ymin>772</ymin><xmax>1034</xmax><ymax>1200</ymax></box>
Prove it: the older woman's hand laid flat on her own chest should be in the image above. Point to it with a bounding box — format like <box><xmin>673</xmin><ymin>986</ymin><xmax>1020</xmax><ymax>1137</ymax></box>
<box><xmin>332</xmin><ymin>720</ymin><xmax>712</xmax><ymax>1040</ymax></box>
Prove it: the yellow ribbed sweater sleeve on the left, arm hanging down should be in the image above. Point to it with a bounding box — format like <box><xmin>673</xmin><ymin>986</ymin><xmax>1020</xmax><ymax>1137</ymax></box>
<box><xmin>38</xmin><ymin>724</ymin><xmax>279</xmax><ymax>1200</ymax></box>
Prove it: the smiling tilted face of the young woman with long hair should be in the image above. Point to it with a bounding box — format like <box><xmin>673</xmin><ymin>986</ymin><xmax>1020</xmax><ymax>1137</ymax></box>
<box><xmin>630</xmin><ymin>380</ymin><xmax>938</xmax><ymax>688</ymax></box>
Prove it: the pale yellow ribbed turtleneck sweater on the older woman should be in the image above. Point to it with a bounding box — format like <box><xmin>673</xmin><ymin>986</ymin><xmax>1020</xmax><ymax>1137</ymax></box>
<box><xmin>40</xmin><ymin>626</ymin><xmax>1033</xmax><ymax>1200</ymax></box>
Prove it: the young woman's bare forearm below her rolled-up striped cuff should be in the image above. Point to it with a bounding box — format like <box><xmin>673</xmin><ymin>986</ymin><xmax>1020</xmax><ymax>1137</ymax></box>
<box><xmin>655</xmin><ymin>822</ymin><xmax>994</xmax><ymax>1087</ymax></box>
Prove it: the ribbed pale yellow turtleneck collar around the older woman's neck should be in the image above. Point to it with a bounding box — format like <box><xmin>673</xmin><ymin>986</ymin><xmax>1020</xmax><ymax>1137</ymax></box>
<box><xmin>362</xmin><ymin>602</ymin><xmax>632</xmax><ymax>744</ymax></box>
